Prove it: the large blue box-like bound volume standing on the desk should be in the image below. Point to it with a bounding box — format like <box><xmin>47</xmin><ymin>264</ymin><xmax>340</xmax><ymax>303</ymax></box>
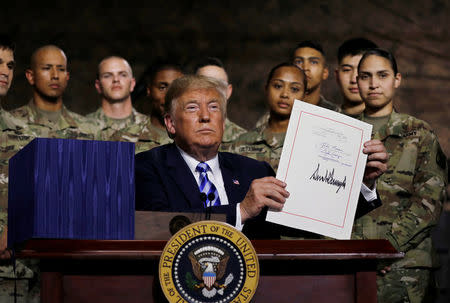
<box><xmin>8</xmin><ymin>138</ymin><xmax>134</xmax><ymax>247</ymax></box>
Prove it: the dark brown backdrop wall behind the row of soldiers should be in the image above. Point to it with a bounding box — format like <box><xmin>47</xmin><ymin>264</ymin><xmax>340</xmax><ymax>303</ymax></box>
<box><xmin>0</xmin><ymin>0</ymin><xmax>450</xmax><ymax>155</ymax></box>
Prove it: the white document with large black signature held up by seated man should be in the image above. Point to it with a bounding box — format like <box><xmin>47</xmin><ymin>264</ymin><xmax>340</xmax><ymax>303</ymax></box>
<box><xmin>266</xmin><ymin>100</ymin><xmax>372</xmax><ymax>239</ymax></box>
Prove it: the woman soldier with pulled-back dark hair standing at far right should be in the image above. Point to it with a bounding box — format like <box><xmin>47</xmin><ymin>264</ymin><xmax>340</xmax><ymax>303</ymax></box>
<box><xmin>353</xmin><ymin>49</ymin><xmax>448</xmax><ymax>303</ymax></box>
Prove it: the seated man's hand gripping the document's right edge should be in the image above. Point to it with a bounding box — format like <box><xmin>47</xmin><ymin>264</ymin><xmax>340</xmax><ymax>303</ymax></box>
<box><xmin>363</xmin><ymin>140</ymin><xmax>389</xmax><ymax>189</ymax></box>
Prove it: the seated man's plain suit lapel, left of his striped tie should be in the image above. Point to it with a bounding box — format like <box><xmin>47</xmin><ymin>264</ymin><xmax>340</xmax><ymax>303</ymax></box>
<box><xmin>166</xmin><ymin>144</ymin><xmax>203</xmax><ymax>208</ymax></box>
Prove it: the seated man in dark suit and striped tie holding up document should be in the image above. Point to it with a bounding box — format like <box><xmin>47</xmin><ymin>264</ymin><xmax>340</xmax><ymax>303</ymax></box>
<box><xmin>135</xmin><ymin>76</ymin><xmax>387</xmax><ymax>236</ymax></box>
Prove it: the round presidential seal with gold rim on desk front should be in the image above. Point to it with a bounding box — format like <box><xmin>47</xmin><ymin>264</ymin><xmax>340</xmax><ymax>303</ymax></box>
<box><xmin>159</xmin><ymin>221</ymin><xmax>259</xmax><ymax>303</ymax></box>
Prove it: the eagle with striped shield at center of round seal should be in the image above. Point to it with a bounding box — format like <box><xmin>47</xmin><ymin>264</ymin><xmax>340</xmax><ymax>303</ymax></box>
<box><xmin>188</xmin><ymin>245</ymin><xmax>233</xmax><ymax>298</ymax></box>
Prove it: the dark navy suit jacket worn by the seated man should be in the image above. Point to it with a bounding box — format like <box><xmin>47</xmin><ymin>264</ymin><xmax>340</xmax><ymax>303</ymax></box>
<box><xmin>135</xmin><ymin>144</ymin><xmax>378</xmax><ymax>238</ymax></box>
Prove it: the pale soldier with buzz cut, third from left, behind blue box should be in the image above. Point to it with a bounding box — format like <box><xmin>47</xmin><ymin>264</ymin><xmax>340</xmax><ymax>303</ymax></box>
<box><xmin>87</xmin><ymin>56</ymin><xmax>165</xmax><ymax>152</ymax></box>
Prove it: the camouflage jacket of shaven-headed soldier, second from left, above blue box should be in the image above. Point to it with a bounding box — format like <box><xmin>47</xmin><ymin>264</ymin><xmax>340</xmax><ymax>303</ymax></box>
<box><xmin>10</xmin><ymin>100</ymin><xmax>96</xmax><ymax>139</ymax></box>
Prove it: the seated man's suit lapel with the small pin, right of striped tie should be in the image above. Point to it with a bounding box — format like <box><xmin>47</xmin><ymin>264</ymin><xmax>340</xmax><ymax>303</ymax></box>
<box><xmin>219</xmin><ymin>153</ymin><xmax>245</xmax><ymax>204</ymax></box>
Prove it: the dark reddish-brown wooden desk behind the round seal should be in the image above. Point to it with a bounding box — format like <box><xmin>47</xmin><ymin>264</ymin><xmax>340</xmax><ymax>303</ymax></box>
<box><xmin>17</xmin><ymin>239</ymin><xmax>402</xmax><ymax>303</ymax></box>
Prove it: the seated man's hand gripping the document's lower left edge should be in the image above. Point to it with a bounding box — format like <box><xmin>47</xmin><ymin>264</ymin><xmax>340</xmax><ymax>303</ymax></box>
<box><xmin>240</xmin><ymin>177</ymin><xmax>289</xmax><ymax>223</ymax></box>
